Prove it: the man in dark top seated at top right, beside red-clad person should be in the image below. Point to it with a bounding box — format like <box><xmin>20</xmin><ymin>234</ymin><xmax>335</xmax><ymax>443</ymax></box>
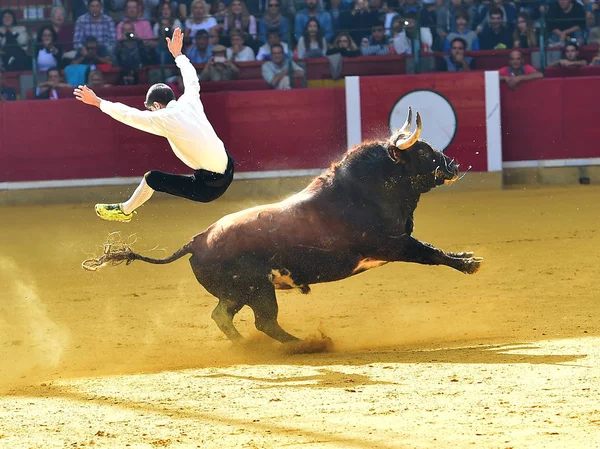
<box><xmin>546</xmin><ymin>0</ymin><xmax>585</xmax><ymax>44</ymax></box>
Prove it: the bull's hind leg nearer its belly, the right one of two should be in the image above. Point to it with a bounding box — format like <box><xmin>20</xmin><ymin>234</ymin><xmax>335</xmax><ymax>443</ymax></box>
<box><xmin>248</xmin><ymin>283</ymin><xmax>300</xmax><ymax>343</ymax></box>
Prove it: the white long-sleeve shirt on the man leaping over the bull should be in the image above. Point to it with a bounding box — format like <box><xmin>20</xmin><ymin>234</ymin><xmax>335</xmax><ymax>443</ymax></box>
<box><xmin>100</xmin><ymin>54</ymin><xmax>228</xmax><ymax>173</ymax></box>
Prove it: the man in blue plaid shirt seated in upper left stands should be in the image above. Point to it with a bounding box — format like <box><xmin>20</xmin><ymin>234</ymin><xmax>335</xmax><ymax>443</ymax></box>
<box><xmin>73</xmin><ymin>0</ymin><xmax>117</xmax><ymax>53</ymax></box>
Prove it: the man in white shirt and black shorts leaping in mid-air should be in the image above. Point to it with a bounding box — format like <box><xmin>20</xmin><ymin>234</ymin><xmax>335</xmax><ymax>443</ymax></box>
<box><xmin>74</xmin><ymin>28</ymin><xmax>235</xmax><ymax>222</ymax></box>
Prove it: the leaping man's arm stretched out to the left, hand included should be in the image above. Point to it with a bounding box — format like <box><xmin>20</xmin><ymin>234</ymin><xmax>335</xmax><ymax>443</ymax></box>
<box><xmin>73</xmin><ymin>86</ymin><xmax>166</xmax><ymax>136</ymax></box>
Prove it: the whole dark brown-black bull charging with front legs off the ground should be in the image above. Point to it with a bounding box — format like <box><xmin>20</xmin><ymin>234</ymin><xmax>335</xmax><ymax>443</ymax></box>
<box><xmin>86</xmin><ymin>109</ymin><xmax>482</xmax><ymax>343</ymax></box>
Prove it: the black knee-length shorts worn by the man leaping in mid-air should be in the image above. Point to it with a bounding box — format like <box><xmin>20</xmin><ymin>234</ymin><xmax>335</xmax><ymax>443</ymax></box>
<box><xmin>144</xmin><ymin>154</ymin><xmax>235</xmax><ymax>203</ymax></box>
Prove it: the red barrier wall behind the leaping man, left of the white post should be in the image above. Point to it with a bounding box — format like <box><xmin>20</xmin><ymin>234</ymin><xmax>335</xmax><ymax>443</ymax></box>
<box><xmin>0</xmin><ymin>89</ymin><xmax>346</xmax><ymax>181</ymax></box>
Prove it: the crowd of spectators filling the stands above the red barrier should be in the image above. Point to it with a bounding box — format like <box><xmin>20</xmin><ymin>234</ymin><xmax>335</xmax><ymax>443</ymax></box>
<box><xmin>0</xmin><ymin>0</ymin><xmax>600</xmax><ymax>101</ymax></box>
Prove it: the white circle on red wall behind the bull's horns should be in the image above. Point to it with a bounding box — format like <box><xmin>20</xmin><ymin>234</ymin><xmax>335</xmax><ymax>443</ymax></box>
<box><xmin>389</xmin><ymin>90</ymin><xmax>457</xmax><ymax>151</ymax></box>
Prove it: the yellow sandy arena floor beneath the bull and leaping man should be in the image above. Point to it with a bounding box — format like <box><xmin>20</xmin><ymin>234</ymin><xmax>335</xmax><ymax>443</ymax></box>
<box><xmin>0</xmin><ymin>186</ymin><xmax>600</xmax><ymax>449</ymax></box>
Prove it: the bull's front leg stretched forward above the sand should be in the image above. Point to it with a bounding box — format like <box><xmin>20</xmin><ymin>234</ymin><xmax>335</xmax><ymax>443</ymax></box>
<box><xmin>389</xmin><ymin>236</ymin><xmax>483</xmax><ymax>274</ymax></box>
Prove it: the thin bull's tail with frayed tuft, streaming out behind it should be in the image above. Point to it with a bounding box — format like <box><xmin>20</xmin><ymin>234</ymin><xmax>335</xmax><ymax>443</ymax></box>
<box><xmin>81</xmin><ymin>233</ymin><xmax>192</xmax><ymax>271</ymax></box>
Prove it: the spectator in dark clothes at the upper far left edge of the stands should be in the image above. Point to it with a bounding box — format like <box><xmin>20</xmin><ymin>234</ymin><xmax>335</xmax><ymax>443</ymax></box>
<box><xmin>0</xmin><ymin>9</ymin><xmax>31</xmax><ymax>71</ymax></box>
